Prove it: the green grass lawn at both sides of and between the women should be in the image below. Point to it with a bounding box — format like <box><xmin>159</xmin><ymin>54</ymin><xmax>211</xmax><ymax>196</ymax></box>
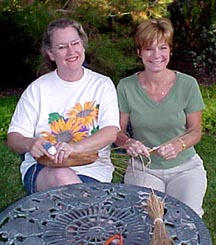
<box><xmin>0</xmin><ymin>97</ymin><xmax>216</xmax><ymax>245</ymax></box>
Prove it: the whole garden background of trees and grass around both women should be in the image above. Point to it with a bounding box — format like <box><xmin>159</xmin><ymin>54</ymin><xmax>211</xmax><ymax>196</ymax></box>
<box><xmin>0</xmin><ymin>0</ymin><xmax>216</xmax><ymax>244</ymax></box>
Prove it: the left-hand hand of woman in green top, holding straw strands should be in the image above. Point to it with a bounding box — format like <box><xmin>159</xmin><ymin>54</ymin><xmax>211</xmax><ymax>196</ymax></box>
<box><xmin>124</xmin><ymin>138</ymin><xmax>150</xmax><ymax>157</ymax></box>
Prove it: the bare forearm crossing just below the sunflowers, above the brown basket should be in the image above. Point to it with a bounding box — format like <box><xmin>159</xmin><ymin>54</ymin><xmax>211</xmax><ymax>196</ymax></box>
<box><xmin>73</xmin><ymin>126</ymin><xmax>118</xmax><ymax>152</ymax></box>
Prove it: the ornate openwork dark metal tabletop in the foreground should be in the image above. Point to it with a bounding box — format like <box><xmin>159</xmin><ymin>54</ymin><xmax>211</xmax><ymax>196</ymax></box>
<box><xmin>0</xmin><ymin>183</ymin><xmax>211</xmax><ymax>245</ymax></box>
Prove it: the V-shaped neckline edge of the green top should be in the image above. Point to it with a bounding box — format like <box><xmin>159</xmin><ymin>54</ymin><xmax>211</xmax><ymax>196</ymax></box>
<box><xmin>135</xmin><ymin>71</ymin><xmax>179</xmax><ymax>105</ymax></box>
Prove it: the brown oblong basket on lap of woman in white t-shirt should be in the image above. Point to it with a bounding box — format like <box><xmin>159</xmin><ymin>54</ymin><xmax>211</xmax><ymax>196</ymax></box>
<box><xmin>37</xmin><ymin>152</ymin><xmax>98</xmax><ymax>168</ymax></box>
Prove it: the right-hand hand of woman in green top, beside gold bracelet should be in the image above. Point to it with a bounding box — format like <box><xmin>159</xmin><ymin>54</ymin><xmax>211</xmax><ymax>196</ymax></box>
<box><xmin>157</xmin><ymin>141</ymin><xmax>182</xmax><ymax>160</ymax></box>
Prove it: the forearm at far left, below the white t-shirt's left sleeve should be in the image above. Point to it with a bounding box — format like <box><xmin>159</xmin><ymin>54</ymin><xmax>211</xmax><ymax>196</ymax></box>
<box><xmin>7</xmin><ymin>132</ymin><xmax>34</xmax><ymax>154</ymax></box>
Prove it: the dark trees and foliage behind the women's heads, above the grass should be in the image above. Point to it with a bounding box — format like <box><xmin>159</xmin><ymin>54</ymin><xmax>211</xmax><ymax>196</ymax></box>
<box><xmin>0</xmin><ymin>0</ymin><xmax>216</xmax><ymax>88</ymax></box>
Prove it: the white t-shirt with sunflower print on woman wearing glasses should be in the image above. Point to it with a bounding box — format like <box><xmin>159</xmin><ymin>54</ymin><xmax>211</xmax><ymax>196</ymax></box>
<box><xmin>8</xmin><ymin>68</ymin><xmax>119</xmax><ymax>182</ymax></box>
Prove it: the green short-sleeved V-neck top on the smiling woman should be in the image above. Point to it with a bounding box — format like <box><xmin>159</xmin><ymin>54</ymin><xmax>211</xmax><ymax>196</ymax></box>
<box><xmin>117</xmin><ymin>72</ymin><xmax>204</xmax><ymax>169</ymax></box>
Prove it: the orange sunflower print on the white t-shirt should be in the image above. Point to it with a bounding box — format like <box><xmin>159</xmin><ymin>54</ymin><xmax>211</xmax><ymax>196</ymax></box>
<box><xmin>41</xmin><ymin>101</ymin><xmax>99</xmax><ymax>144</ymax></box>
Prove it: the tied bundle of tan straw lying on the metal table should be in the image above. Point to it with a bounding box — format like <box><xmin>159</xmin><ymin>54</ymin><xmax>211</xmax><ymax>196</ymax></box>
<box><xmin>147</xmin><ymin>192</ymin><xmax>173</xmax><ymax>245</ymax></box>
